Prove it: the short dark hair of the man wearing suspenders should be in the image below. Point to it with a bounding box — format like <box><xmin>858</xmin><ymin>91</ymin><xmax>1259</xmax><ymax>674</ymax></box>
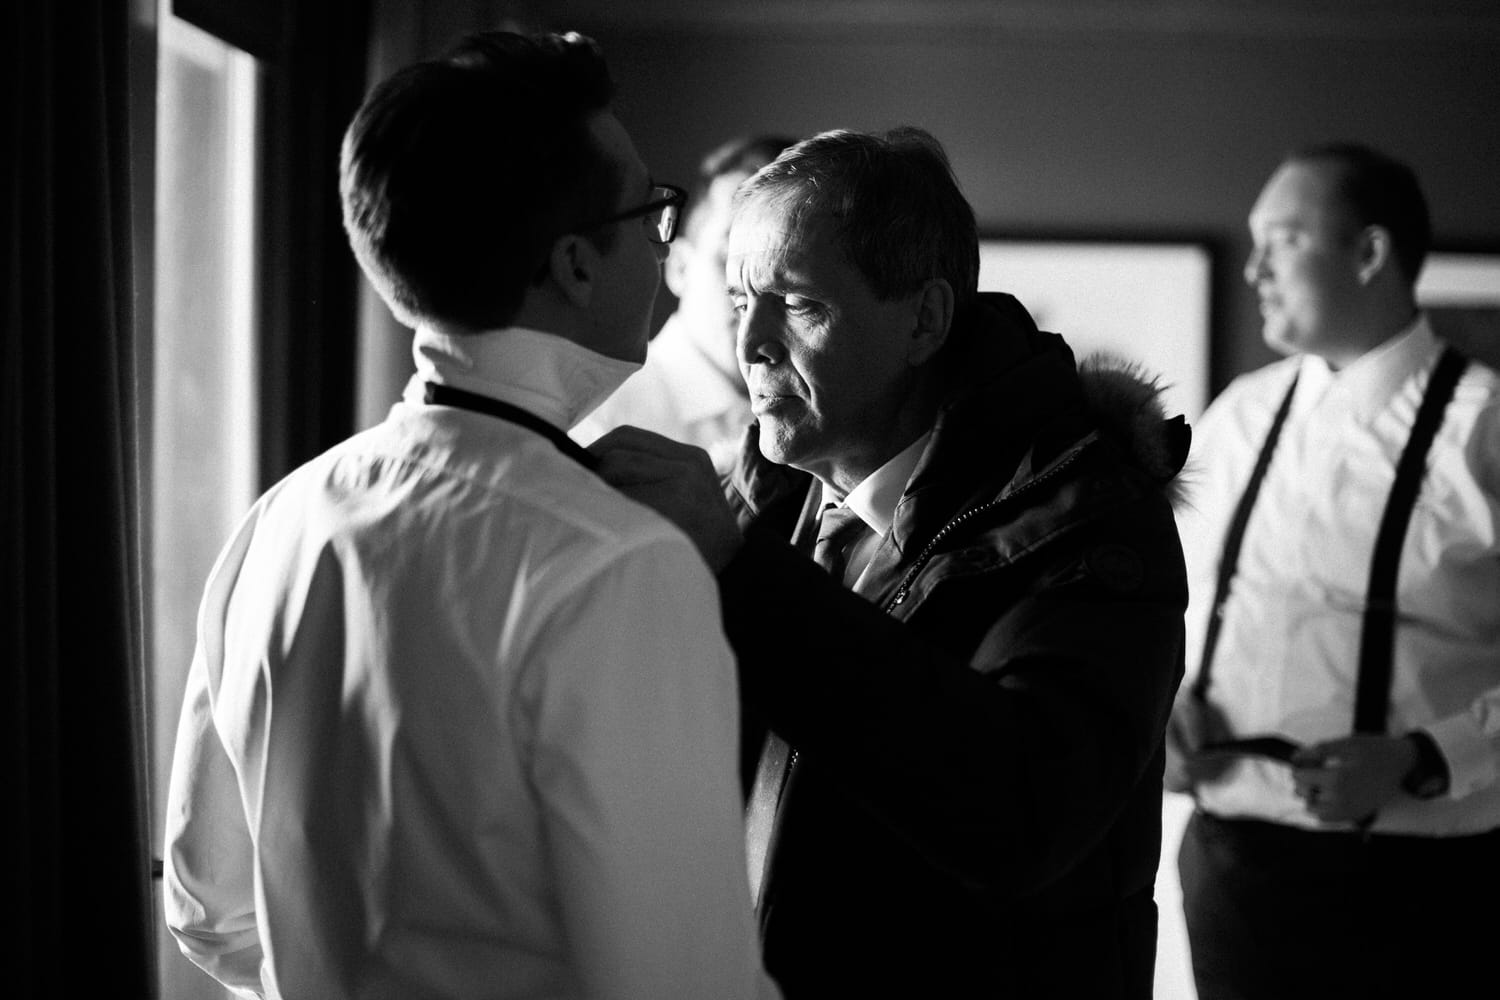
<box><xmin>1284</xmin><ymin>142</ymin><xmax>1433</xmax><ymax>285</ymax></box>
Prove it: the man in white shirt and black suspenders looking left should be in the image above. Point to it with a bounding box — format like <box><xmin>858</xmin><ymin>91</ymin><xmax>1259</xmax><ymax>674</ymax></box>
<box><xmin>1167</xmin><ymin>144</ymin><xmax>1500</xmax><ymax>1000</ymax></box>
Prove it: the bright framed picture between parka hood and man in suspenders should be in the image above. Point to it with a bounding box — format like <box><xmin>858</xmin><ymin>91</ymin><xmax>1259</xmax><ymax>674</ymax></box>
<box><xmin>980</xmin><ymin>238</ymin><xmax>1214</xmax><ymax>421</ymax></box>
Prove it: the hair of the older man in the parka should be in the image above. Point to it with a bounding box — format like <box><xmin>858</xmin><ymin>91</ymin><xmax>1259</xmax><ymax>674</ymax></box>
<box><xmin>735</xmin><ymin>126</ymin><xmax>980</xmax><ymax>309</ymax></box>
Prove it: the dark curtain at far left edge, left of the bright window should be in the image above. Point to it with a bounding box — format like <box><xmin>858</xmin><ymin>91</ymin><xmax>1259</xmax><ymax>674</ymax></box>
<box><xmin>0</xmin><ymin>0</ymin><xmax>153</xmax><ymax>997</ymax></box>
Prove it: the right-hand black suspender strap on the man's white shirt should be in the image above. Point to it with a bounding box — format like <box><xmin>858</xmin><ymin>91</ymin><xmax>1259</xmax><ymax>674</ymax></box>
<box><xmin>1355</xmin><ymin>348</ymin><xmax>1469</xmax><ymax>733</ymax></box>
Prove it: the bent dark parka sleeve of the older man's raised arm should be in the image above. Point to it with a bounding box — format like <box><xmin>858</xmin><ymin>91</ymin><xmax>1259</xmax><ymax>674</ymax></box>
<box><xmin>720</xmin><ymin>498</ymin><xmax>1187</xmax><ymax>895</ymax></box>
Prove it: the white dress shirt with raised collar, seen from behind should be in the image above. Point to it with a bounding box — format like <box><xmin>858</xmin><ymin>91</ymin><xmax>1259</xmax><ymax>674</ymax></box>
<box><xmin>164</xmin><ymin>328</ymin><xmax>774</xmax><ymax>1000</ymax></box>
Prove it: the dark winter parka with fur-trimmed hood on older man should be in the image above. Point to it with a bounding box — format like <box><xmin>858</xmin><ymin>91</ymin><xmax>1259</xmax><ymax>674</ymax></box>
<box><xmin>720</xmin><ymin>295</ymin><xmax>1188</xmax><ymax>1000</ymax></box>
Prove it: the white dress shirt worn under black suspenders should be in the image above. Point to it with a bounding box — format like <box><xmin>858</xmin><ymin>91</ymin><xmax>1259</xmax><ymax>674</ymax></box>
<box><xmin>1179</xmin><ymin>318</ymin><xmax>1500</xmax><ymax>835</ymax></box>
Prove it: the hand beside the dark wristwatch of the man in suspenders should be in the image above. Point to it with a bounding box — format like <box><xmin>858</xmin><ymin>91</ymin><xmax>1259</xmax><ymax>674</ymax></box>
<box><xmin>1292</xmin><ymin>735</ymin><xmax>1416</xmax><ymax>823</ymax></box>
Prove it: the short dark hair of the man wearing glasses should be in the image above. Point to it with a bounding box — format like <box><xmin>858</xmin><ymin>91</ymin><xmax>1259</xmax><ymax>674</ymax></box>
<box><xmin>339</xmin><ymin>31</ymin><xmax>623</xmax><ymax>330</ymax></box>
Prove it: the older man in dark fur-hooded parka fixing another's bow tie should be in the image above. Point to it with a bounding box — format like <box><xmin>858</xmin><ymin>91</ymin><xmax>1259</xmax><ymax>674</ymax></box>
<box><xmin>597</xmin><ymin>129</ymin><xmax>1188</xmax><ymax>999</ymax></box>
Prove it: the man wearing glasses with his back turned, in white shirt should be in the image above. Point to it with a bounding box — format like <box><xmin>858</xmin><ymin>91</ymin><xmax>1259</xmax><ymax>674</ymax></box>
<box><xmin>165</xmin><ymin>33</ymin><xmax>776</xmax><ymax>1000</ymax></box>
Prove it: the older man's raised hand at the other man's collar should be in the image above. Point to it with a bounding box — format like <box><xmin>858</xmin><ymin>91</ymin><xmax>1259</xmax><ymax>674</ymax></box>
<box><xmin>588</xmin><ymin>427</ymin><xmax>744</xmax><ymax>573</ymax></box>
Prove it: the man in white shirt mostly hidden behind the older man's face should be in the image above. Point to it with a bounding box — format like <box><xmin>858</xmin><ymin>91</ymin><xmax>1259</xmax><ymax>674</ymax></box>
<box><xmin>573</xmin><ymin>135</ymin><xmax>795</xmax><ymax>471</ymax></box>
